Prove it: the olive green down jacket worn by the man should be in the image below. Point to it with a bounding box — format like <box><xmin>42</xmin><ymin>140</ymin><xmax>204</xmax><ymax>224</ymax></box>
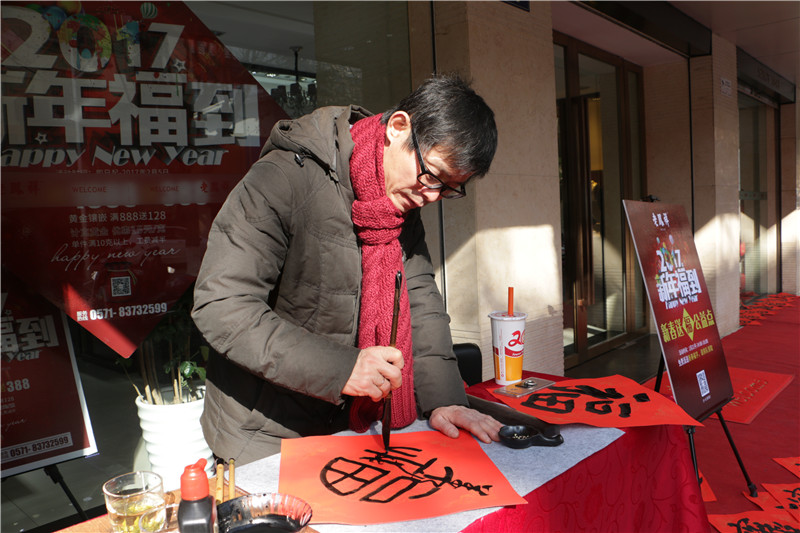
<box><xmin>192</xmin><ymin>106</ymin><xmax>467</xmax><ymax>464</ymax></box>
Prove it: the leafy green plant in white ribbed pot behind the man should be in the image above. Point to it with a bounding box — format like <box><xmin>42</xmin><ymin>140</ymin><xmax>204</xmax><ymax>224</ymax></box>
<box><xmin>120</xmin><ymin>287</ymin><xmax>214</xmax><ymax>490</ymax></box>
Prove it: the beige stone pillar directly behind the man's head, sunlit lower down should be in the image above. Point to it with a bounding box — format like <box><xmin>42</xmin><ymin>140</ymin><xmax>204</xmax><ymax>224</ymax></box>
<box><xmin>409</xmin><ymin>2</ymin><xmax>564</xmax><ymax>378</ymax></box>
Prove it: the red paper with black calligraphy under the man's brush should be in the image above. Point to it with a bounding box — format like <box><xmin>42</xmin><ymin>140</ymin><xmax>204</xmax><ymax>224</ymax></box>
<box><xmin>279</xmin><ymin>431</ymin><xmax>525</xmax><ymax>525</ymax></box>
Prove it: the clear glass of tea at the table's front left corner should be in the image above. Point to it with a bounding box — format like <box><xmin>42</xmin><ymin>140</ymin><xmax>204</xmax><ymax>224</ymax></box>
<box><xmin>103</xmin><ymin>472</ymin><xmax>165</xmax><ymax>533</ymax></box>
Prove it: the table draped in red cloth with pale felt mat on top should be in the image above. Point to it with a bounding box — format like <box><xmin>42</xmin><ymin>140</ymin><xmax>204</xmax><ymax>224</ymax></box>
<box><xmin>228</xmin><ymin>372</ymin><xmax>710</xmax><ymax>533</ymax></box>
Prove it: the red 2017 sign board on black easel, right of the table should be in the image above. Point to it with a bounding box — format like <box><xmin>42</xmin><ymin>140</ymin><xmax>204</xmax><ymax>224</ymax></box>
<box><xmin>623</xmin><ymin>200</ymin><xmax>733</xmax><ymax>420</ymax></box>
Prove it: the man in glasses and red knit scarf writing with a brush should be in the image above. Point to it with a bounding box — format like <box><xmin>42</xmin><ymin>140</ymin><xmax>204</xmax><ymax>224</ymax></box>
<box><xmin>192</xmin><ymin>77</ymin><xmax>502</xmax><ymax>464</ymax></box>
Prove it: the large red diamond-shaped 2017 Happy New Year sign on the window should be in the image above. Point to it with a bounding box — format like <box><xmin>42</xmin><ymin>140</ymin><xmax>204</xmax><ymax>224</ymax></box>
<box><xmin>1</xmin><ymin>2</ymin><xmax>286</xmax><ymax>357</ymax></box>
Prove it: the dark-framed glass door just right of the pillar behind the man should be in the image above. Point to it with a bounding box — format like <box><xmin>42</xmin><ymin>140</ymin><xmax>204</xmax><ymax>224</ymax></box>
<box><xmin>555</xmin><ymin>36</ymin><xmax>646</xmax><ymax>368</ymax></box>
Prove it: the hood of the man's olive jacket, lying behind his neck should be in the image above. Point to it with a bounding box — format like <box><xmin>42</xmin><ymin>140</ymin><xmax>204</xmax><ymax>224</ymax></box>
<box><xmin>260</xmin><ymin>105</ymin><xmax>372</xmax><ymax>176</ymax></box>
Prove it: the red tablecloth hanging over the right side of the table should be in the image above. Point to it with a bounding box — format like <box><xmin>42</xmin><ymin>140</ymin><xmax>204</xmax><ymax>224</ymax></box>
<box><xmin>463</xmin><ymin>372</ymin><xmax>711</xmax><ymax>533</ymax></box>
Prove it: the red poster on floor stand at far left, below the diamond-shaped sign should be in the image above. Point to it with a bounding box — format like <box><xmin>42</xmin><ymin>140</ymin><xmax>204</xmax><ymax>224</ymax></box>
<box><xmin>0</xmin><ymin>269</ymin><xmax>97</xmax><ymax>477</ymax></box>
